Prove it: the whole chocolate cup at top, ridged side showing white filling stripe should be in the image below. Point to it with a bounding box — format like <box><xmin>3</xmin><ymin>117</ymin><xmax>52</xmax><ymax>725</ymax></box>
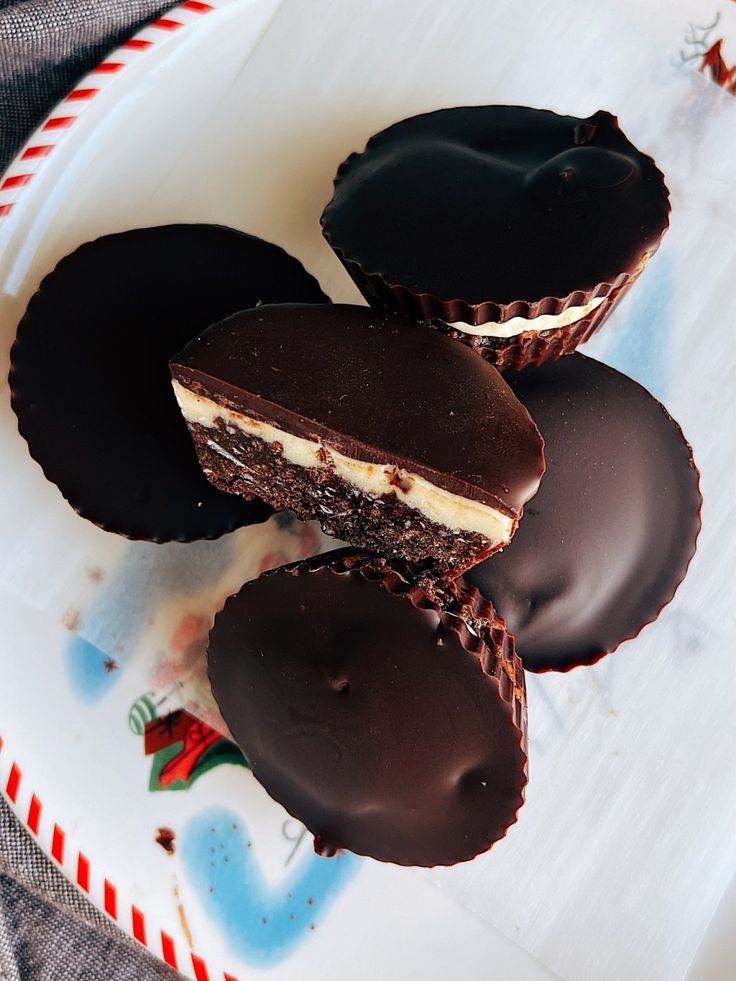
<box><xmin>322</xmin><ymin>106</ymin><xmax>670</xmax><ymax>369</ymax></box>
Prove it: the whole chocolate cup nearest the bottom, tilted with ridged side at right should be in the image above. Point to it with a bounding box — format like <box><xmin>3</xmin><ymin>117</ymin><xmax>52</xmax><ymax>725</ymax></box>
<box><xmin>209</xmin><ymin>550</ymin><xmax>526</xmax><ymax>866</ymax></box>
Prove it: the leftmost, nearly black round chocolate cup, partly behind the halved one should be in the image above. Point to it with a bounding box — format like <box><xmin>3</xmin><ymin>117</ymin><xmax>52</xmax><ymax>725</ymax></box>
<box><xmin>10</xmin><ymin>225</ymin><xmax>326</xmax><ymax>541</ymax></box>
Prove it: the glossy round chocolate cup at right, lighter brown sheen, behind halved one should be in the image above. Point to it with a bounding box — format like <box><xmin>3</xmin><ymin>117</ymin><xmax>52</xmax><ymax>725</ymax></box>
<box><xmin>466</xmin><ymin>354</ymin><xmax>701</xmax><ymax>671</ymax></box>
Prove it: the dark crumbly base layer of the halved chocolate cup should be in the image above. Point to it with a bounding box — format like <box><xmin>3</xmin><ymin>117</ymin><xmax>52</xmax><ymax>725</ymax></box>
<box><xmin>189</xmin><ymin>423</ymin><xmax>500</xmax><ymax>583</ymax></box>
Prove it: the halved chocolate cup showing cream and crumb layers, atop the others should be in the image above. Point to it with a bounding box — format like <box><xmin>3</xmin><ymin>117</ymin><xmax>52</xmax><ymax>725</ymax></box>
<box><xmin>170</xmin><ymin>304</ymin><xmax>544</xmax><ymax>576</ymax></box>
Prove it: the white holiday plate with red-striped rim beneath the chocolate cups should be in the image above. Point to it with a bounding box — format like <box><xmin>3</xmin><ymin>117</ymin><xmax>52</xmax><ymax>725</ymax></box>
<box><xmin>0</xmin><ymin>0</ymin><xmax>733</xmax><ymax>981</ymax></box>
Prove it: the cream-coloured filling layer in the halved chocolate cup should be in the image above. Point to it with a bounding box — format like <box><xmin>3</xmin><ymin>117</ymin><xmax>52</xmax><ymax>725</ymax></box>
<box><xmin>172</xmin><ymin>380</ymin><xmax>514</xmax><ymax>543</ymax></box>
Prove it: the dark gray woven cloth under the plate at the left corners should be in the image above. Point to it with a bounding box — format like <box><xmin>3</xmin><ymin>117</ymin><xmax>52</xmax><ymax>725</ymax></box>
<box><xmin>0</xmin><ymin>9</ymin><xmax>185</xmax><ymax>981</ymax></box>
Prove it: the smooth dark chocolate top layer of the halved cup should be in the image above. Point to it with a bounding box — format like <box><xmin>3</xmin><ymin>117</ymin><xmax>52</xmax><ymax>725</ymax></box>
<box><xmin>171</xmin><ymin>304</ymin><xmax>544</xmax><ymax>516</ymax></box>
